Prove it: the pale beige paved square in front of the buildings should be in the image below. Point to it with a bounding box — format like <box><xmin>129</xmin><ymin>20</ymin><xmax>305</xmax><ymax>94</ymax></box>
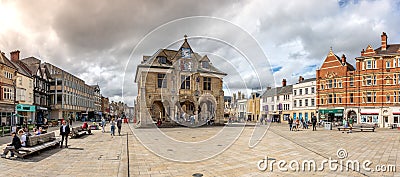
<box><xmin>0</xmin><ymin>124</ymin><xmax>400</xmax><ymax>177</ymax></box>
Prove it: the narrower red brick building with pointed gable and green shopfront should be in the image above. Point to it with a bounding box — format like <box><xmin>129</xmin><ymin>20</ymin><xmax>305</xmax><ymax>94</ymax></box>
<box><xmin>316</xmin><ymin>49</ymin><xmax>355</xmax><ymax>122</ymax></box>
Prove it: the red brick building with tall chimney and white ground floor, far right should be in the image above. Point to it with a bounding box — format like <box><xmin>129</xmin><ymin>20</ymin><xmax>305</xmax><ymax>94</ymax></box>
<box><xmin>356</xmin><ymin>32</ymin><xmax>400</xmax><ymax>127</ymax></box>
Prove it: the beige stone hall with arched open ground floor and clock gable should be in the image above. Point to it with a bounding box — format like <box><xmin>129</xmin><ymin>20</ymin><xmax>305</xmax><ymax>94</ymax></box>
<box><xmin>135</xmin><ymin>36</ymin><xmax>226</xmax><ymax>125</ymax></box>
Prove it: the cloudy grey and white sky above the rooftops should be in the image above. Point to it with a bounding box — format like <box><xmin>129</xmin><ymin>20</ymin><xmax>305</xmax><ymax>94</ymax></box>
<box><xmin>0</xmin><ymin>0</ymin><xmax>400</xmax><ymax>105</ymax></box>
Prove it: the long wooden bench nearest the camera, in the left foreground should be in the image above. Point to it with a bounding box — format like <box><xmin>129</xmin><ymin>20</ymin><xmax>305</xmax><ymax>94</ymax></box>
<box><xmin>11</xmin><ymin>132</ymin><xmax>61</xmax><ymax>158</ymax></box>
